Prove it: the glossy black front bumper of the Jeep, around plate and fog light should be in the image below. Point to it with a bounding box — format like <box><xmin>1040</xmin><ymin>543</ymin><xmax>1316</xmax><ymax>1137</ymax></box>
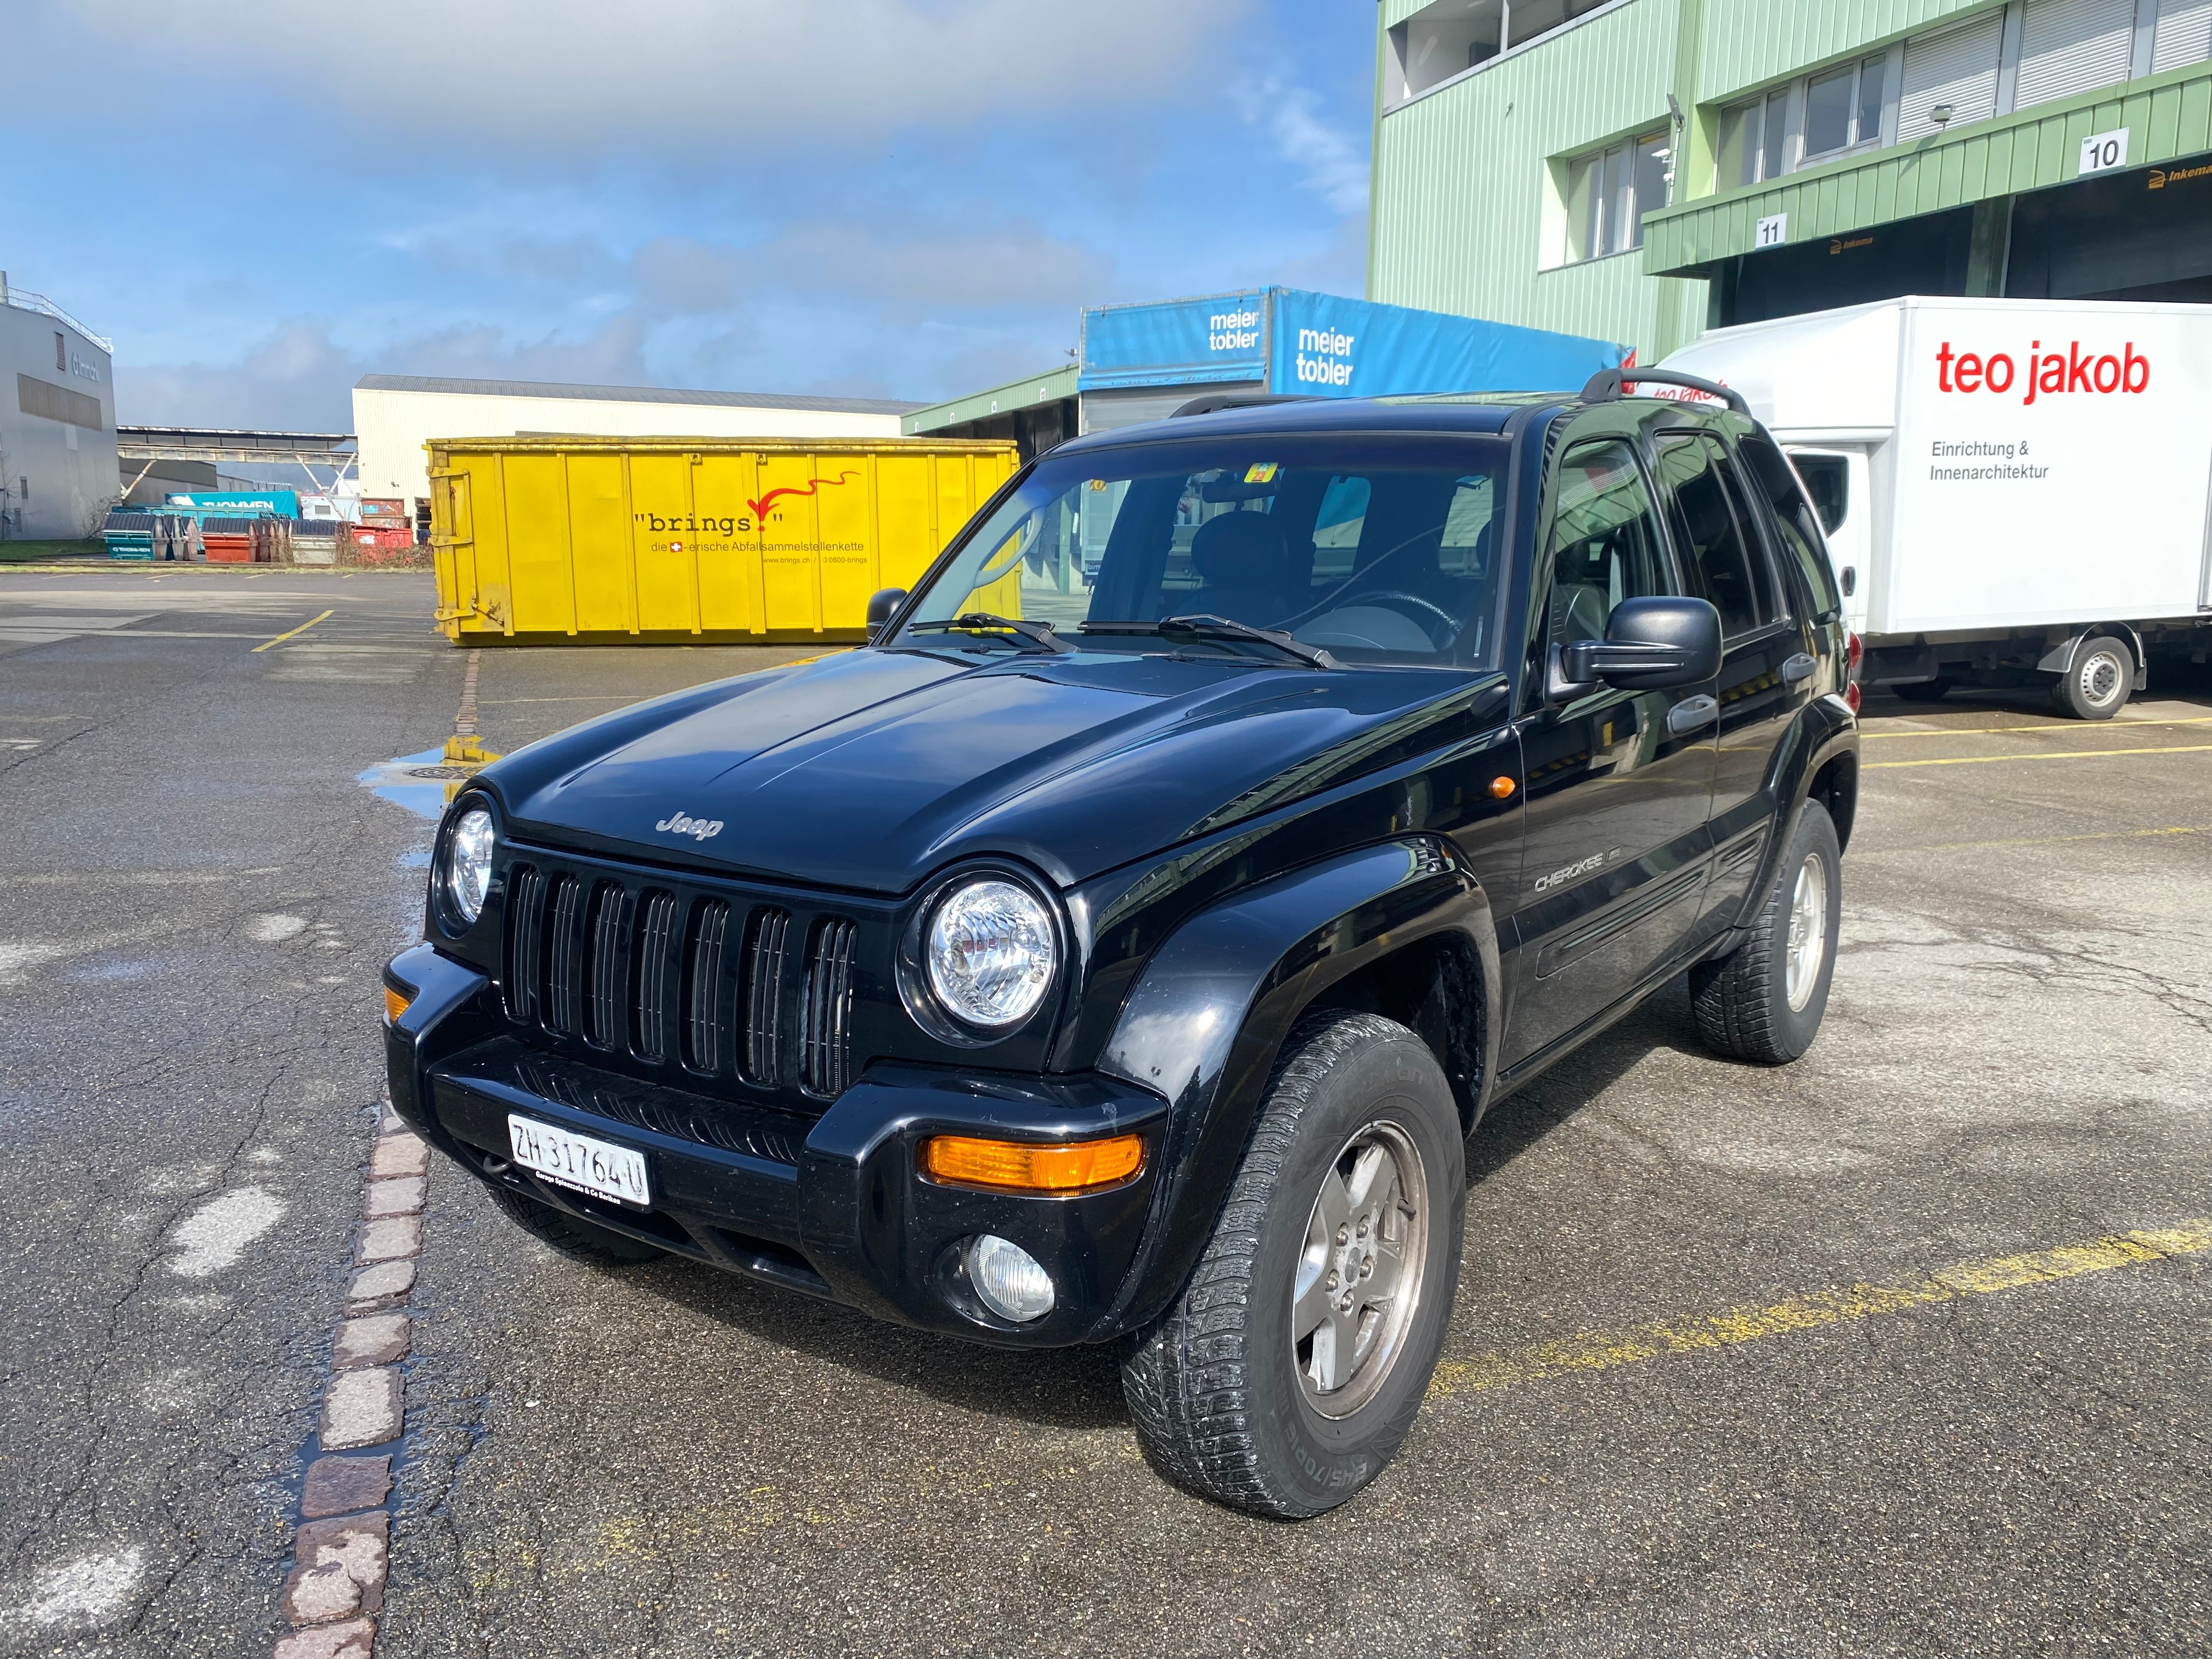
<box><xmin>385</xmin><ymin>945</ymin><xmax>1168</xmax><ymax>1347</ymax></box>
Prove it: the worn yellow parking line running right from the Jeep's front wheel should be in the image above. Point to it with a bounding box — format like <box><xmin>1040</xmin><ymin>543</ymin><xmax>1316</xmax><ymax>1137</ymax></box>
<box><xmin>1429</xmin><ymin>1221</ymin><xmax>2212</xmax><ymax>1398</ymax></box>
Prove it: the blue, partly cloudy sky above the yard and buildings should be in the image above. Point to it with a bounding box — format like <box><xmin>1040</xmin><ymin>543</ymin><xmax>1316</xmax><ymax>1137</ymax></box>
<box><xmin>0</xmin><ymin>0</ymin><xmax>1374</xmax><ymax>431</ymax></box>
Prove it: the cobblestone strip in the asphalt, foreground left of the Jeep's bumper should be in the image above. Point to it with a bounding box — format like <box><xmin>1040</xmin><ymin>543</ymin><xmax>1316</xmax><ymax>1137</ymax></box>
<box><xmin>274</xmin><ymin>1106</ymin><xmax>429</xmax><ymax>1659</ymax></box>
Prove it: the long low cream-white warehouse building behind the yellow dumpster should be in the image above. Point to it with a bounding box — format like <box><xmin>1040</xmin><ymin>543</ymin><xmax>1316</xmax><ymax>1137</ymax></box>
<box><xmin>354</xmin><ymin>374</ymin><xmax>922</xmax><ymax>533</ymax></box>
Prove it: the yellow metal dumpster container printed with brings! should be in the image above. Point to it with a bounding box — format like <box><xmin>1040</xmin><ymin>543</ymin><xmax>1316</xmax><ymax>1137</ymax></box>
<box><xmin>425</xmin><ymin>436</ymin><xmax>1018</xmax><ymax>646</ymax></box>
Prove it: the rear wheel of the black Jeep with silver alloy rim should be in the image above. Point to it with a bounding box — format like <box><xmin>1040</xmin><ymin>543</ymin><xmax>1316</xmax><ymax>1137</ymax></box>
<box><xmin>1690</xmin><ymin>801</ymin><xmax>1843</xmax><ymax>1066</ymax></box>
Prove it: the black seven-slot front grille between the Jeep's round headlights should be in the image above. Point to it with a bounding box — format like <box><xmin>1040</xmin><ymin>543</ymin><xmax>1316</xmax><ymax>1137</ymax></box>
<box><xmin>502</xmin><ymin>858</ymin><xmax>862</xmax><ymax>1102</ymax></box>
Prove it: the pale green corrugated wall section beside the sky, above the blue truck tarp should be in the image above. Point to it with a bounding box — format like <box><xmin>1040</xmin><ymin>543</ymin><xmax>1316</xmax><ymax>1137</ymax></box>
<box><xmin>1369</xmin><ymin>0</ymin><xmax>1706</xmax><ymax>358</ymax></box>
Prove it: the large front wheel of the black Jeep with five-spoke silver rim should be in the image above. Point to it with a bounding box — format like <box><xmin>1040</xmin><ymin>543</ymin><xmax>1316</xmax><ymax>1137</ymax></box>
<box><xmin>1121</xmin><ymin>1013</ymin><xmax>1466</xmax><ymax>1520</ymax></box>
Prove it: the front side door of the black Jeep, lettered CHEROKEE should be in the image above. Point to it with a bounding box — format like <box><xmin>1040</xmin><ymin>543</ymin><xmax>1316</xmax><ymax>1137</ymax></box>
<box><xmin>1504</xmin><ymin>438</ymin><xmax>1717</xmax><ymax>1066</ymax></box>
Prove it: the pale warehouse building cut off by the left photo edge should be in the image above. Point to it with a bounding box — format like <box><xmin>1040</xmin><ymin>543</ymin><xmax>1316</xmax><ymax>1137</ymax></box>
<box><xmin>0</xmin><ymin>272</ymin><xmax>119</xmax><ymax>542</ymax></box>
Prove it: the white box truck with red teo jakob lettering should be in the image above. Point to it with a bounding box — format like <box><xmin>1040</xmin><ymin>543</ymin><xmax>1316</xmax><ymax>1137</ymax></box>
<box><xmin>1652</xmin><ymin>296</ymin><xmax>2212</xmax><ymax>719</ymax></box>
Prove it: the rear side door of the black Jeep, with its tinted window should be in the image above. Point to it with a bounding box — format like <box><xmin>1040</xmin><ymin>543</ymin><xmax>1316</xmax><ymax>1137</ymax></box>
<box><xmin>1657</xmin><ymin>427</ymin><xmax>1820</xmax><ymax>927</ymax></box>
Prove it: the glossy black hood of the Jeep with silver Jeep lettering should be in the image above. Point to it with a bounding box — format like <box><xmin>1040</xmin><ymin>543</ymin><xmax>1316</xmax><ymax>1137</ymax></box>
<box><xmin>482</xmin><ymin>650</ymin><xmax>1504</xmax><ymax>894</ymax></box>
